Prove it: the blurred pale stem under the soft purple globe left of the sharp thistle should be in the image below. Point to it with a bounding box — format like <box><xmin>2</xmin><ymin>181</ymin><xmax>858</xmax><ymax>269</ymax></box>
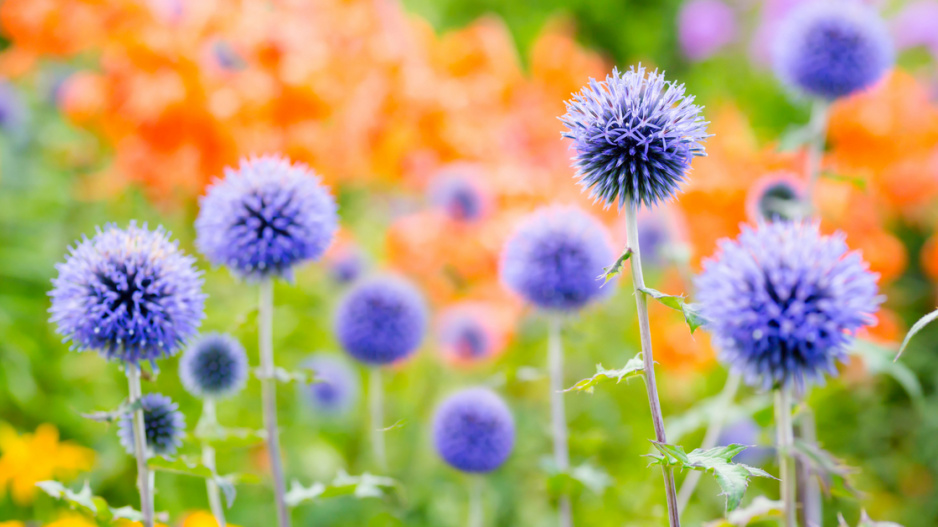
<box><xmin>547</xmin><ymin>316</ymin><xmax>573</xmax><ymax>527</ymax></box>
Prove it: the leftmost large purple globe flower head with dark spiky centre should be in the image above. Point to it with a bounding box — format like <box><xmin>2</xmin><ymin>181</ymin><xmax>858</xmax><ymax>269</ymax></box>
<box><xmin>49</xmin><ymin>222</ymin><xmax>205</xmax><ymax>365</ymax></box>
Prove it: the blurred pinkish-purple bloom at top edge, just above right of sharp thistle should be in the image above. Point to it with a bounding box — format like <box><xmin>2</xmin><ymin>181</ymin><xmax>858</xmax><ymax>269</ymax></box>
<box><xmin>677</xmin><ymin>0</ymin><xmax>737</xmax><ymax>61</ymax></box>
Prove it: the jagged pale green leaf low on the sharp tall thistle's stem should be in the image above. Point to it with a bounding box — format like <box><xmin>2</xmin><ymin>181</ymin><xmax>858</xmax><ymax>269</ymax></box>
<box><xmin>648</xmin><ymin>441</ymin><xmax>775</xmax><ymax>512</ymax></box>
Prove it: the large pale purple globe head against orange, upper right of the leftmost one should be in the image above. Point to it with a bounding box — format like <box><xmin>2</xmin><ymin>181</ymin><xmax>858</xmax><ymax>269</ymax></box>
<box><xmin>195</xmin><ymin>156</ymin><xmax>338</xmax><ymax>280</ymax></box>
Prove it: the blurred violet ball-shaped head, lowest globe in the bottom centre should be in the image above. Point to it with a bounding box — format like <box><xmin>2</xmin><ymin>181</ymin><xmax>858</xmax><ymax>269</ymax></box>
<box><xmin>433</xmin><ymin>388</ymin><xmax>515</xmax><ymax>473</ymax></box>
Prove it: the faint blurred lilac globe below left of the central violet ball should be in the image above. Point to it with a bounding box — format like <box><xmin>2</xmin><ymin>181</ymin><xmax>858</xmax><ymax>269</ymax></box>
<box><xmin>303</xmin><ymin>353</ymin><xmax>361</xmax><ymax>414</ymax></box>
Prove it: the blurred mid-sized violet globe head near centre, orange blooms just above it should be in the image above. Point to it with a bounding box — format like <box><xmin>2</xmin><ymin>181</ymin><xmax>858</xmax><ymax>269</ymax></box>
<box><xmin>335</xmin><ymin>276</ymin><xmax>427</xmax><ymax>366</ymax></box>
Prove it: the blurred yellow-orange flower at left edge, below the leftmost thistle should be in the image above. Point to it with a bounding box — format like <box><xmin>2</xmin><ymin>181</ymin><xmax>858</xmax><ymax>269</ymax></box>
<box><xmin>0</xmin><ymin>423</ymin><xmax>94</xmax><ymax>505</ymax></box>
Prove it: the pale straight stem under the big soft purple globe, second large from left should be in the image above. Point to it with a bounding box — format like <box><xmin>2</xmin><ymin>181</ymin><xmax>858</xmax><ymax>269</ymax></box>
<box><xmin>258</xmin><ymin>279</ymin><xmax>290</xmax><ymax>527</ymax></box>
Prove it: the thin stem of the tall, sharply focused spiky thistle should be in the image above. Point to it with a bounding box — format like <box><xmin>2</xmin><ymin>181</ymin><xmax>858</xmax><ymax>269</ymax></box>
<box><xmin>626</xmin><ymin>203</ymin><xmax>681</xmax><ymax>527</ymax></box>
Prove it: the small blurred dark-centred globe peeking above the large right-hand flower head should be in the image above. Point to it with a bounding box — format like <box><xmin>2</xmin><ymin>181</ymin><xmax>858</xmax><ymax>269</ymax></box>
<box><xmin>746</xmin><ymin>172</ymin><xmax>807</xmax><ymax>222</ymax></box>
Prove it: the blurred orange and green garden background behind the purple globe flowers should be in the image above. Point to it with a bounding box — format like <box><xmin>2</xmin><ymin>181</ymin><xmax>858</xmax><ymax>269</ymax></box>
<box><xmin>0</xmin><ymin>0</ymin><xmax>938</xmax><ymax>527</ymax></box>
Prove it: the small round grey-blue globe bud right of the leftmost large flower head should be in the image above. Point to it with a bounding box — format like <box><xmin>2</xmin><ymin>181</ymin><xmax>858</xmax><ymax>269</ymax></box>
<box><xmin>179</xmin><ymin>333</ymin><xmax>248</xmax><ymax>399</ymax></box>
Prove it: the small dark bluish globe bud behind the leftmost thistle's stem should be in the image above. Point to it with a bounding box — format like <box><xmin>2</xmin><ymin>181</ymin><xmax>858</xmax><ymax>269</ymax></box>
<box><xmin>117</xmin><ymin>393</ymin><xmax>186</xmax><ymax>456</ymax></box>
